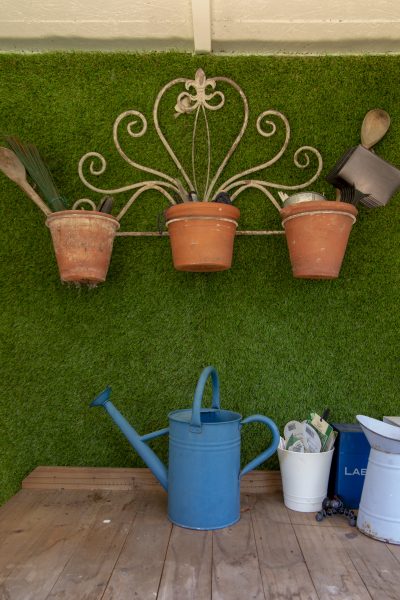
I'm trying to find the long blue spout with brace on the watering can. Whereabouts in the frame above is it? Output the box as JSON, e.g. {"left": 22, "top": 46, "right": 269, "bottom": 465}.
{"left": 90, "top": 386, "right": 169, "bottom": 490}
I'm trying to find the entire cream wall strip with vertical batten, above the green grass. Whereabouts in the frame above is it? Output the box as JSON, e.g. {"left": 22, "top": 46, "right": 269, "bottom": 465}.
{"left": 0, "top": 0, "right": 400, "bottom": 54}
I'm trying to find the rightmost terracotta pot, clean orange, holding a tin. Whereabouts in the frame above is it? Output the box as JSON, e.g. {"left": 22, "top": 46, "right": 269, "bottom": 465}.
{"left": 281, "top": 200, "right": 358, "bottom": 279}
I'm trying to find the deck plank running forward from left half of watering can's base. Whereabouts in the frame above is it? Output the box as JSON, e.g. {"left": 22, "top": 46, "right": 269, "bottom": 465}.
{"left": 157, "top": 526, "right": 212, "bottom": 600}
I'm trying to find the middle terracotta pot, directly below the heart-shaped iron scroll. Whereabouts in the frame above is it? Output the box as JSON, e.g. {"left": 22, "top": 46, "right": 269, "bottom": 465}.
{"left": 166, "top": 202, "right": 240, "bottom": 272}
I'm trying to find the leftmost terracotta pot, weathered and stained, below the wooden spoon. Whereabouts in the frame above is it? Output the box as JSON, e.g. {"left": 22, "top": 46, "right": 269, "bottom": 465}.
{"left": 46, "top": 210, "right": 119, "bottom": 284}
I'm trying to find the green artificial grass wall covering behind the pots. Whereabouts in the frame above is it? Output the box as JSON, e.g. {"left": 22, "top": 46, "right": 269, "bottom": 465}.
{"left": 0, "top": 53, "right": 400, "bottom": 501}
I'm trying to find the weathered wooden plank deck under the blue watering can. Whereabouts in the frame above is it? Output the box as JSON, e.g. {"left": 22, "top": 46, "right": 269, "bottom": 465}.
{"left": 0, "top": 469, "right": 400, "bottom": 600}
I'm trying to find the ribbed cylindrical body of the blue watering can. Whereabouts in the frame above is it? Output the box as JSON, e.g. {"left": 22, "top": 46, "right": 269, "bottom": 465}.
{"left": 168, "top": 409, "right": 241, "bottom": 529}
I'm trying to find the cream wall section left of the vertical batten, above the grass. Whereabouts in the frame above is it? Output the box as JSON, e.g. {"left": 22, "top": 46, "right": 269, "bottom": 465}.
{"left": 0, "top": 0, "right": 193, "bottom": 50}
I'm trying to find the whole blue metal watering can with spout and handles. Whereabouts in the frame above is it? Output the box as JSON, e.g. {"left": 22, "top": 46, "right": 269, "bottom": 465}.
{"left": 91, "top": 367, "right": 279, "bottom": 529}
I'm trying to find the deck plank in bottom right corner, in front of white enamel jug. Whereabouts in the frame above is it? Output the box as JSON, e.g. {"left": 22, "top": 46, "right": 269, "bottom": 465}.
{"left": 336, "top": 527, "right": 400, "bottom": 600}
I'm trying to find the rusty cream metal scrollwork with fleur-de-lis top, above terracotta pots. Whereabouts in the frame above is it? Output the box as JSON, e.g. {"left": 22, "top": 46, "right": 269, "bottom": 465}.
{"left": 78, "top": 69, "right": 323, "bottom": 235}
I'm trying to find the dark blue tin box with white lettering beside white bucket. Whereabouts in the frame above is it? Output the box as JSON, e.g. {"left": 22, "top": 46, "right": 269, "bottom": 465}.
{"left": 329, "top": 423, "right": 370, "bottom": 509}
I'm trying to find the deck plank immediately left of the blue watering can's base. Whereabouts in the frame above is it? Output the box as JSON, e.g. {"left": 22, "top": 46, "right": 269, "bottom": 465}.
{"left": 102, "top": 490, "right": 172, "bottom": 600}
